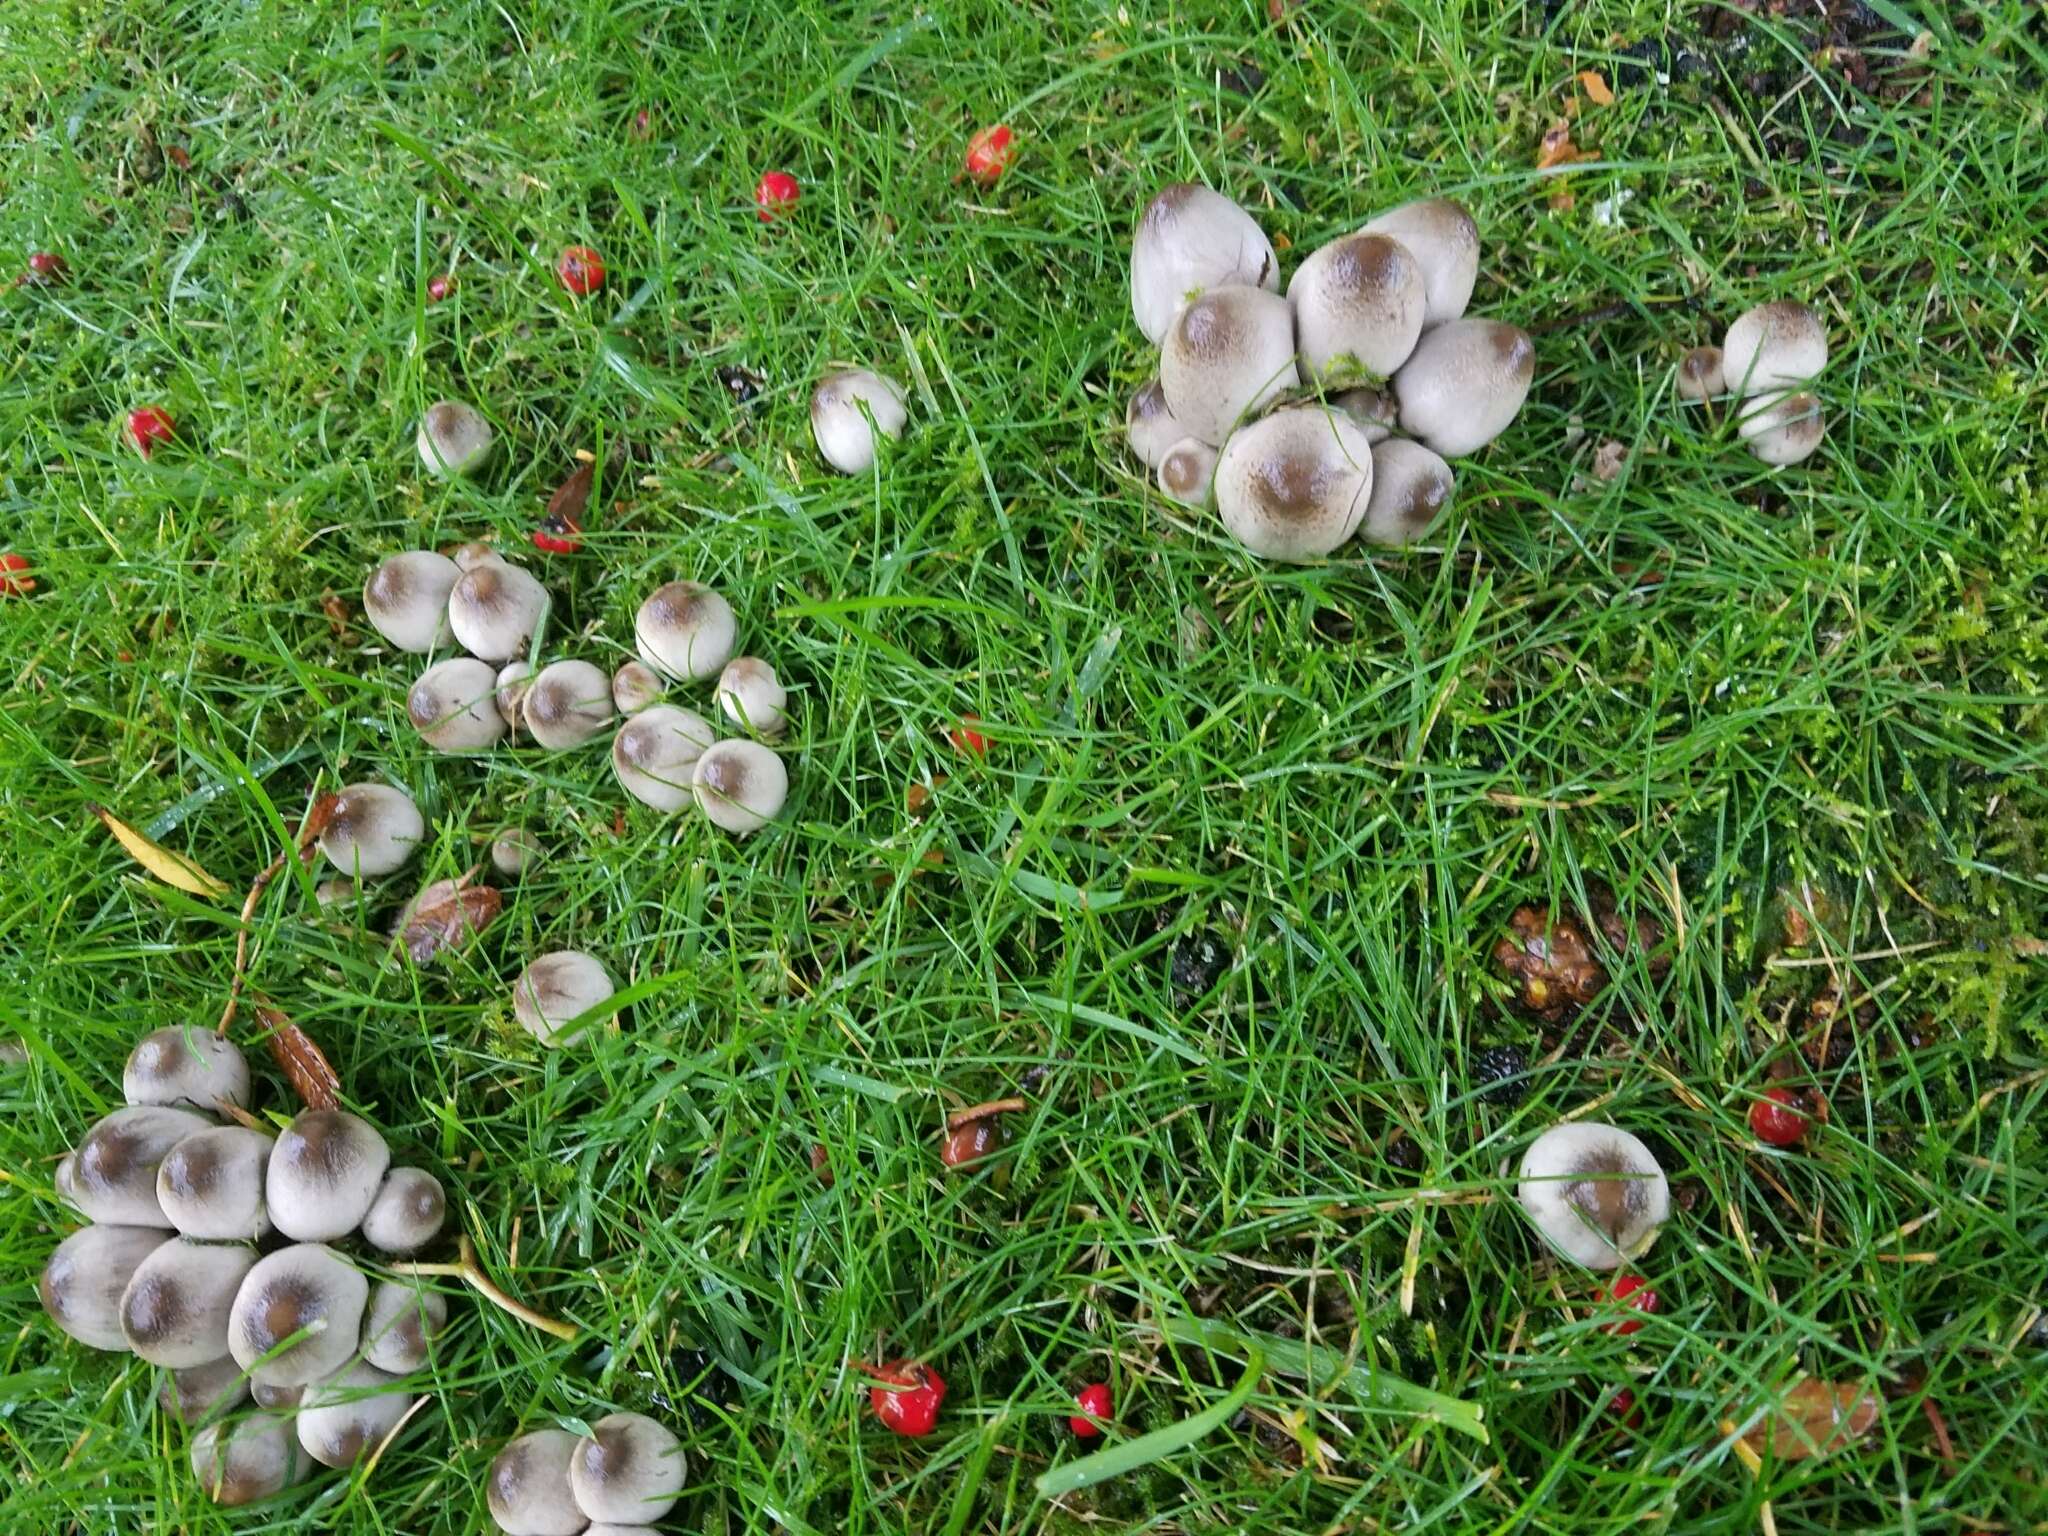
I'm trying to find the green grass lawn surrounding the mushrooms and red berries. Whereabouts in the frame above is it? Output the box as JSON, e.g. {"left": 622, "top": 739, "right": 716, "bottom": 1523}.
{"left": 0, "top": 0, "right": 2048, "bottom": 1536}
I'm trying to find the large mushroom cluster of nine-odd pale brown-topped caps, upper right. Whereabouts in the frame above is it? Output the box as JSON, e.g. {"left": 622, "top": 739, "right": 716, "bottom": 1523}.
{"left": 1124, "top": 182, "right": 1536, "bottom": 561}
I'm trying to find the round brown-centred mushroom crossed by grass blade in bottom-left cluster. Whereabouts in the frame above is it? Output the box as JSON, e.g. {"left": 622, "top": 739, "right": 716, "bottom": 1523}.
{"left": 227, "top": 1243, "right": 371, "bottom": 1386}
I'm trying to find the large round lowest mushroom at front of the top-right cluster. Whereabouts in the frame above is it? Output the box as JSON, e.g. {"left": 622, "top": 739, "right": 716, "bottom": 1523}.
{"left": 1217, "top": 406, "right": 1372, "bottom": 561}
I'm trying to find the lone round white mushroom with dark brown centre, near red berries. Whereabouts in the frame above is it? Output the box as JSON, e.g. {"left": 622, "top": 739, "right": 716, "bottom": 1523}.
{"left": 1516, "top": 1120, "right": 1671, "bottom": 1270}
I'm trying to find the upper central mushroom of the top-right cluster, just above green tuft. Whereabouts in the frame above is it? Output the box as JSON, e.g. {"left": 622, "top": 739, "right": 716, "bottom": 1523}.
{"left": 1286, "top": 236, "right": 1427, "bottom": 383}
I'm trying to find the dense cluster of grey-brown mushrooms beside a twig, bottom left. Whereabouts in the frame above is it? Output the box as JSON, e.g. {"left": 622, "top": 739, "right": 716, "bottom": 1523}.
{"left": 39, "top": 1028, "right": 449, "bottom": 1505}
